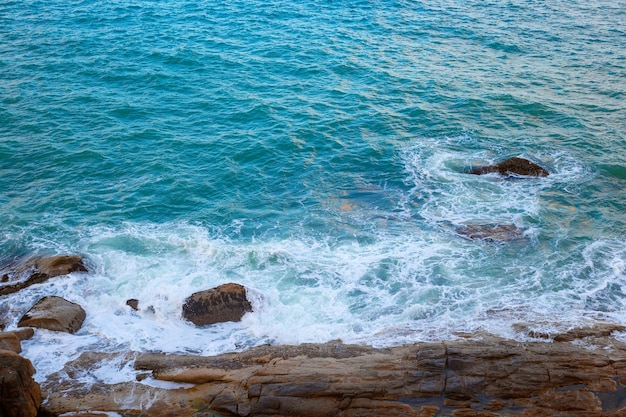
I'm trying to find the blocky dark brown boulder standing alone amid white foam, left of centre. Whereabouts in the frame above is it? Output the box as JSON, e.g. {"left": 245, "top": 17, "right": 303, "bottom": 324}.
{"left": 183, "top": 283, "right": 252, "bottom": 326}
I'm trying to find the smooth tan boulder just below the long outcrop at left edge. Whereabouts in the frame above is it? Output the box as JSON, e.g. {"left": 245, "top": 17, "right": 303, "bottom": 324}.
{"left": 18, "top": 296, "right": 86, "bottom": 333}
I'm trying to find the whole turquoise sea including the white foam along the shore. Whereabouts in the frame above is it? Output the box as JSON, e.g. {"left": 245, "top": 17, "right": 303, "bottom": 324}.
{"left": 0, "top": 0, "right": 626, "bottom": 380}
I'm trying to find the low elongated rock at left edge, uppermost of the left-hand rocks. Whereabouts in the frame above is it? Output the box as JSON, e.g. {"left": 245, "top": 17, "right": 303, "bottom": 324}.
{"left": 0, "top": 255, "right": 87, "bottom": 295}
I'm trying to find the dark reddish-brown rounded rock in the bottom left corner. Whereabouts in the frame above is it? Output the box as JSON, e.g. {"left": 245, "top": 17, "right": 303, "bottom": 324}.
{"left": 0, "top": 350, "right": 41, "bottom": 417}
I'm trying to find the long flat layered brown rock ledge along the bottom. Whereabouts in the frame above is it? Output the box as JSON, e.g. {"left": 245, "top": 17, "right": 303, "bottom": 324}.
{"left": 39, "top": 326, "right": 626, "bottom": 417}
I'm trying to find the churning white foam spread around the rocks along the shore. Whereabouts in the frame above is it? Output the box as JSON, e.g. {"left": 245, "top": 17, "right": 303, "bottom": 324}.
{"left": 9, "top": 138, "right": 626, "bottom": 384}
